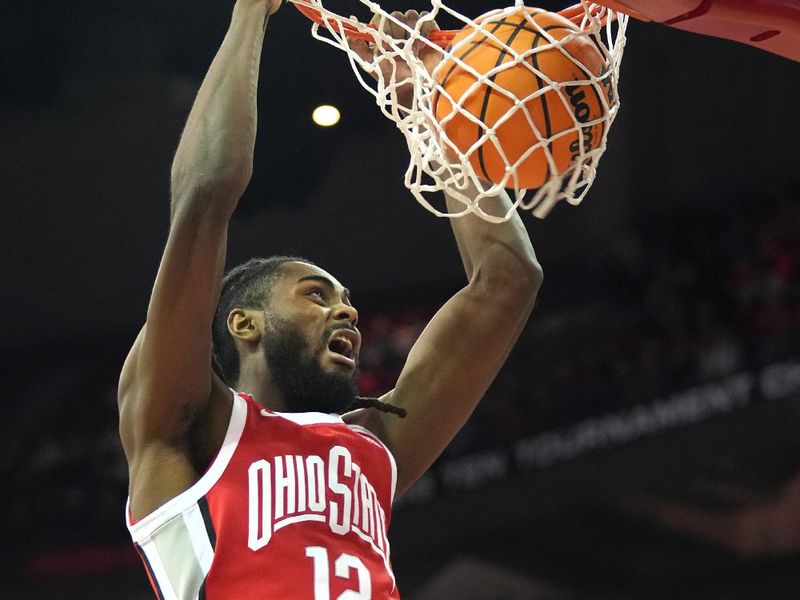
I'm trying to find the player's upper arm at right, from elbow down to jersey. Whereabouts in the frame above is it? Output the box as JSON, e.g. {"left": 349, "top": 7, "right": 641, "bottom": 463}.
{"left": 381, "top": 276, "right": 536, "bottom": 491}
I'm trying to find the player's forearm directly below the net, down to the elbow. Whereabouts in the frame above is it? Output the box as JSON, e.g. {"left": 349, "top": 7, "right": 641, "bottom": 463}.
{"left": 446, "top": 192, "right": 542, "bottom": 292}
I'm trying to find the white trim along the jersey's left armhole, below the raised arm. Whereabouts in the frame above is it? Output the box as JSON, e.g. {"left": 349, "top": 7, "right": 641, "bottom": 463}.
{"left": 125, "top": 392, "right": 247, "bottom": 543}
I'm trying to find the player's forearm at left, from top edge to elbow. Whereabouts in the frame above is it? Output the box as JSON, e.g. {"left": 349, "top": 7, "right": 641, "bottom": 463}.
{"left": 171, "top": 0, "right": 268, "bottom": 216}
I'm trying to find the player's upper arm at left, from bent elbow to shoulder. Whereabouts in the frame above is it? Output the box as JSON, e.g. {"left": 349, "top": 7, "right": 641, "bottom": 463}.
{"left": 119, "top": 209, "right": 227, "bottom": 448}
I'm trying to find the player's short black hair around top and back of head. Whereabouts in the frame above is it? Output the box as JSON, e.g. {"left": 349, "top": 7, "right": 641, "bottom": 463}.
{"left": 211, "top": 256, "right": 314, "bottom": 386}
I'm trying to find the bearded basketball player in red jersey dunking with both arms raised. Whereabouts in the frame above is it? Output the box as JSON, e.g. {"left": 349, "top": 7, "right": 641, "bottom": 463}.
{"left": 119, "top": 0, "right": 542, "bottom": 600}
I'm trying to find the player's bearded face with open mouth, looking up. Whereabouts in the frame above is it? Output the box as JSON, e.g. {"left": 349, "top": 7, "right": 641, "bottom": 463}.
{"left": 263, "top": 262, "right": 361, "bottom": 412}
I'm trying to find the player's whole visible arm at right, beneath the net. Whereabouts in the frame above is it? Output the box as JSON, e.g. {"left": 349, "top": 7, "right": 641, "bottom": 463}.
{"left": 377, "top": 193, "right": 542, "bottom": 493}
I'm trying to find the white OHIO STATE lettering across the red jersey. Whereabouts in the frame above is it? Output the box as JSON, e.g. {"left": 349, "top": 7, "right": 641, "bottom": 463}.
{"left": 247, "top": 446, "right": 389, "bottom": 557}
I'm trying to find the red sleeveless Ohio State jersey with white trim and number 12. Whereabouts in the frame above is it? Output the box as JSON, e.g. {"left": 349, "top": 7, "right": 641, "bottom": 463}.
{"left": 127, "top": 393, "right": 399, "bottom": 600}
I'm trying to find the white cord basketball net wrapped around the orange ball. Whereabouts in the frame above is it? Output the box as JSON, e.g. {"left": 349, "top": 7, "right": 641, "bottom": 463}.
{"left": 292, "top": 0, "right": 628, "bottom": 222}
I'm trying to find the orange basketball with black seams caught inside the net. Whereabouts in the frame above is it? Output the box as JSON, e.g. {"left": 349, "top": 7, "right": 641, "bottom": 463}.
{"left": 433, "top": 9, "right": 613, "bottom": 189}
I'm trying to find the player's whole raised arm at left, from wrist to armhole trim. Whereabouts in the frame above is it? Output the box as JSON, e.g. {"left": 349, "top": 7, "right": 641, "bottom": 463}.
{"left": 119, "top": 0, "right": 279, "bottom": 517}
